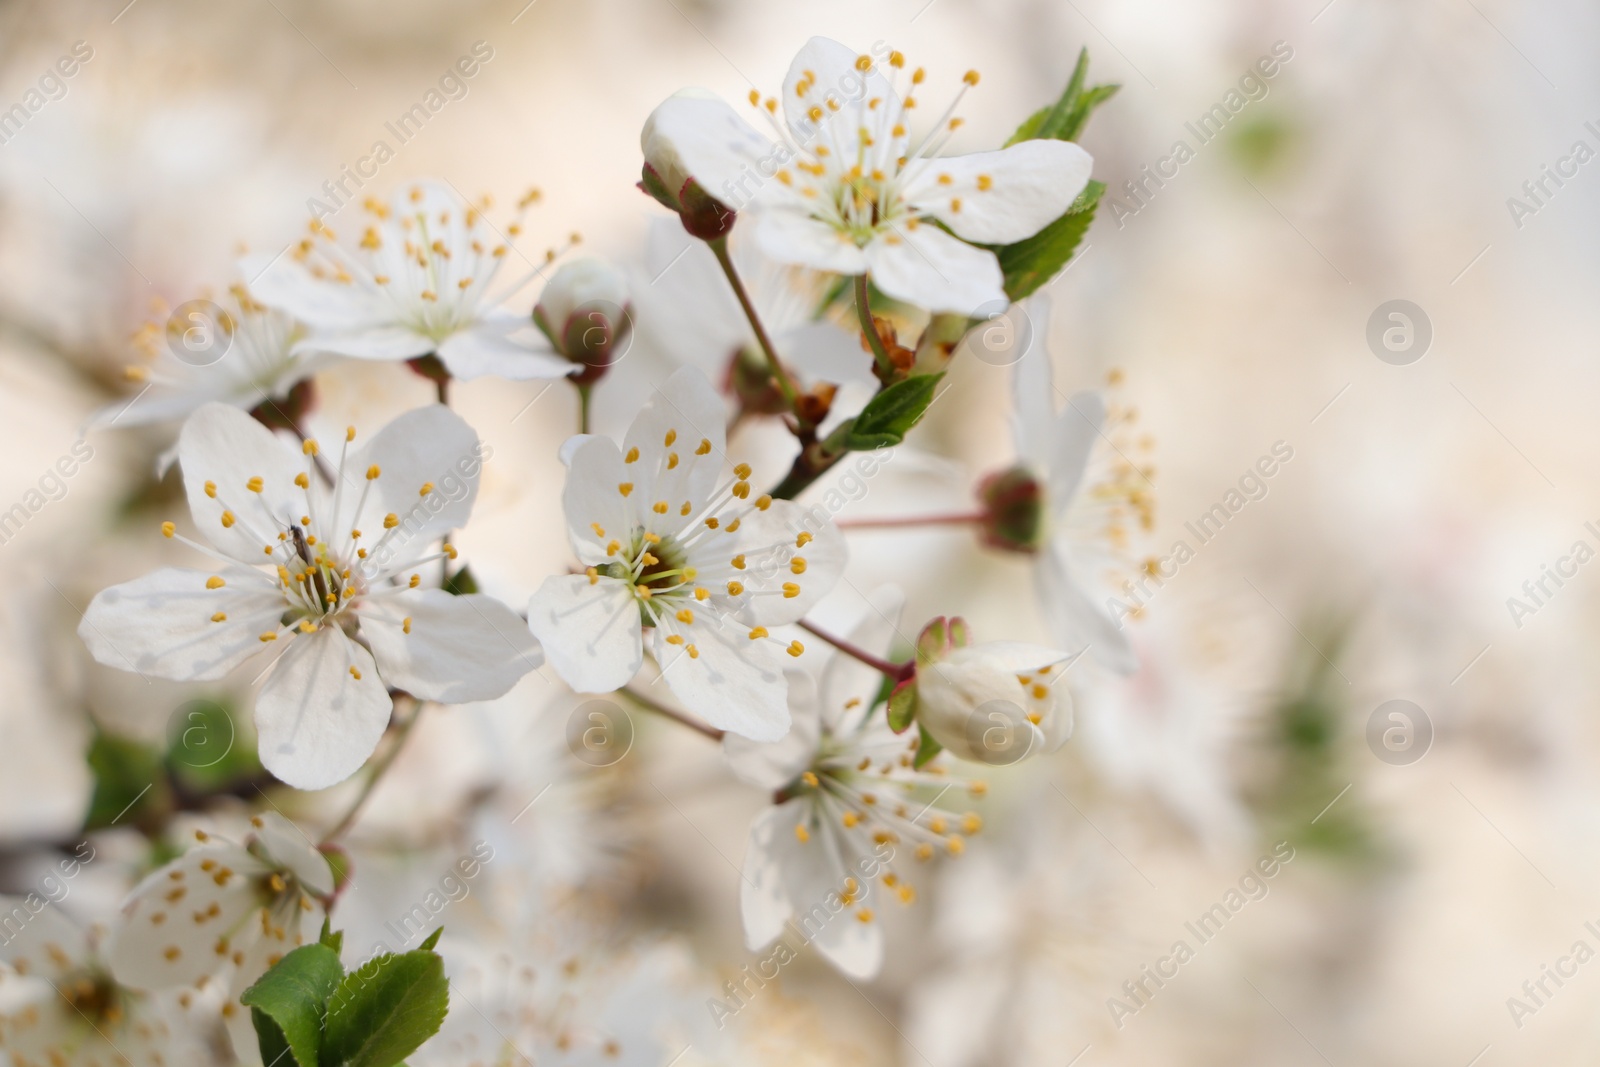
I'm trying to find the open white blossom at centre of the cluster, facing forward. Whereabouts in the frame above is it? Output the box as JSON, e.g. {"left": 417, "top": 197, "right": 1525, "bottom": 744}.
{"left": 528, "top": 368, "right": 845, "bottom": 741}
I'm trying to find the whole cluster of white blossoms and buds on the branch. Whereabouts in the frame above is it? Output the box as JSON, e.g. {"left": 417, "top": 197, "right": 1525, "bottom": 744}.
{"left": 0, "top": 38, "right": 1150, "bottom": 1067}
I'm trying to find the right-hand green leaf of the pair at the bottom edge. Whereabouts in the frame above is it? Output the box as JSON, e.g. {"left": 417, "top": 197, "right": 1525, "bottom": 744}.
{"left": 322, "top": 949, "right": 450, "bottom": 1067}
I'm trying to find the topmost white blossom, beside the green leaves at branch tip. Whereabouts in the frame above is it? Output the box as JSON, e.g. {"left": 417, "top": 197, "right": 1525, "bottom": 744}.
{"left": 642, "top": 37, "right": 1093, "bottom": 314}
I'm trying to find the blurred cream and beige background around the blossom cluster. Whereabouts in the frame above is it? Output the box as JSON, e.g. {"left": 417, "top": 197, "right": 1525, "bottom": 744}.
{"left": 0, "top": 0, "right": 1600, "bottom": 1067}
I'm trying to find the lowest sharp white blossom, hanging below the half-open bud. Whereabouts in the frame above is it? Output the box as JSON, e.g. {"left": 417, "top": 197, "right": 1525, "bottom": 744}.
{"left": 723, "top": 595, "right": 984, "bottom": 979}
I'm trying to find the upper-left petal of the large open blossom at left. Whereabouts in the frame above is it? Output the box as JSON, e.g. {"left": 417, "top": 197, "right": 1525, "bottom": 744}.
{"left": 178, "top": 403, "right": 315, "bottom": 566}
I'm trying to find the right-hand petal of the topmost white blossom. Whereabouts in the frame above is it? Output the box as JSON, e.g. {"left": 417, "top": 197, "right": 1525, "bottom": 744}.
{"left": 906, "top": 139, "right": 1094, "bottom": 245}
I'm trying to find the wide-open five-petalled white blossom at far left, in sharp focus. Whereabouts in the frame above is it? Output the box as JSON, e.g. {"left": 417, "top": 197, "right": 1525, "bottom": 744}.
{"left": 78, "top": 405, "right": 539, "bottom": 789}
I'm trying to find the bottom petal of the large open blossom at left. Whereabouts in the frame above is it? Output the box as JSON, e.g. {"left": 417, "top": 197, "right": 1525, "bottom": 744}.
{"left": 256, "top": 625, "right": 394, "bottom": 789}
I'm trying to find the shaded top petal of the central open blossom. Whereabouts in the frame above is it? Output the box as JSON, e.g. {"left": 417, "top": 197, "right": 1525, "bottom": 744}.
{"left": 622, "top": 366, "right": 728, "bottom": 536}
